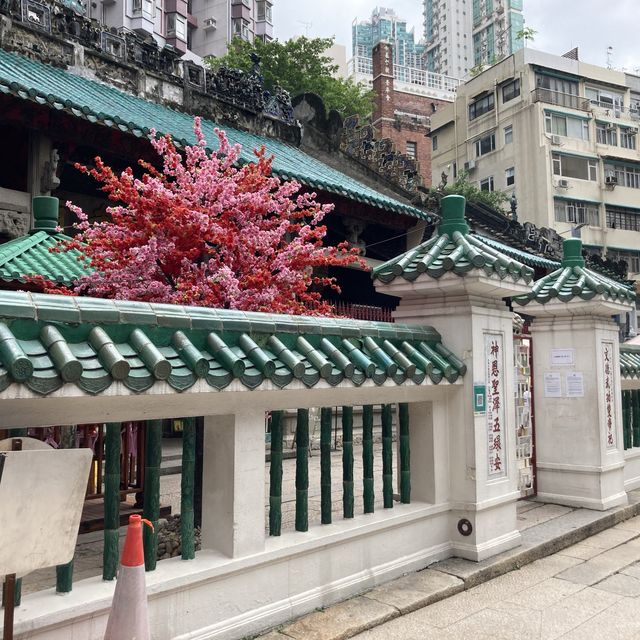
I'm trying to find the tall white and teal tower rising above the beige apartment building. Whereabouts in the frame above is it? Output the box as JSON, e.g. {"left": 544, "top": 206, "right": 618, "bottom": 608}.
{"left": 424, "top": 0, "right": 523, "bottom": 78}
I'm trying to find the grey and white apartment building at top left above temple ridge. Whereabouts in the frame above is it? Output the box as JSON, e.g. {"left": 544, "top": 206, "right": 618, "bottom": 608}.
{"left": 87, "top": 0, "right": 273, "bottom": 61}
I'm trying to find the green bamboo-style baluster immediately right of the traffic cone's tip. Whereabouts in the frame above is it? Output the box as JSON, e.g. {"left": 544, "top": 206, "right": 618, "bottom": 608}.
{"left": 142, "top": 420, "right": 162, "bottom": 571}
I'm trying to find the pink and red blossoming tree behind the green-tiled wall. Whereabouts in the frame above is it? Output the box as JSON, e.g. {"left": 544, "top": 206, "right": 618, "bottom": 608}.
{"left": 39, "top": 118, "right": 365, "bottom": 315}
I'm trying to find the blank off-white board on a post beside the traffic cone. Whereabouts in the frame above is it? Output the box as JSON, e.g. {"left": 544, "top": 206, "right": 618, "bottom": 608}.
{"left": 0, "top": 449, "right": 93, "bottom": 576}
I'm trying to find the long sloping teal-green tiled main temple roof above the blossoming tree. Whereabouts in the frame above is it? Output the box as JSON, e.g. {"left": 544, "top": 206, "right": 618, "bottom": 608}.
{"left": 0, "top": 50, "right": 430, "bottom": 220}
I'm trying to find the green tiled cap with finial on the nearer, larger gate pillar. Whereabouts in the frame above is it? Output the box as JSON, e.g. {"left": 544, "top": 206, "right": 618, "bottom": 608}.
{"left": 373, "top": 195, "right": 533, "bottom": 283}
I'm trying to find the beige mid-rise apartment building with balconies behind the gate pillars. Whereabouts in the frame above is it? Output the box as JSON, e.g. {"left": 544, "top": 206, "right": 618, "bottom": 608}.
{"left": 430, "top": 49, "right": 640, "bottom": 275}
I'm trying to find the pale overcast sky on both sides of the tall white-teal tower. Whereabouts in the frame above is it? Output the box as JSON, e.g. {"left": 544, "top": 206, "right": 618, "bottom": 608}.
{"left": 273, "top": 0, "right": 640, "bottom": 73}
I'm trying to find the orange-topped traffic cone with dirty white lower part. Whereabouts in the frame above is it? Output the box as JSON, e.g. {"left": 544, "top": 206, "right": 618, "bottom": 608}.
{"left": 104, "top": 515, "right": 151, "bottom": 640}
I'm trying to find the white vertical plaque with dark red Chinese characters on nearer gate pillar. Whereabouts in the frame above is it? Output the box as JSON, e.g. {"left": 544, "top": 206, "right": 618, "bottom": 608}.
{"left": 484, "top": 333, "right": 506, "bottom": 477}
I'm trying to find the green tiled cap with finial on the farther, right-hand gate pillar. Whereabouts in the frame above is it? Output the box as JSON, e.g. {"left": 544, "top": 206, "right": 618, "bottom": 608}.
{"left": 513, "top": 238, "right": 636, "bottom": 305}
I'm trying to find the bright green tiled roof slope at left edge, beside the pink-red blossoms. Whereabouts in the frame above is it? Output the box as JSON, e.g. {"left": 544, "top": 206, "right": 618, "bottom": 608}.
{"left": 0, "top": 231, "right": 90, "bottom": 285}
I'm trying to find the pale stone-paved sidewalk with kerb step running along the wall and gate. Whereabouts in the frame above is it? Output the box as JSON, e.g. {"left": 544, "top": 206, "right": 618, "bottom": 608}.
{"left": 260, "top": 491, "right": 640, "bottom": 640}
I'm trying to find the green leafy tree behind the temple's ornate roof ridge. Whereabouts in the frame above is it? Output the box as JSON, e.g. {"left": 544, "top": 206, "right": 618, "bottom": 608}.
{"left": 206, "top": 36, "right": 373, "bottom": 117}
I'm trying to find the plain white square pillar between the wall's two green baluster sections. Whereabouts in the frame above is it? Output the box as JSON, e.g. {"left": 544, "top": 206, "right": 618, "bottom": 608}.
{"left": 202, "top": 410, "right": 265, "bottom": 558}
